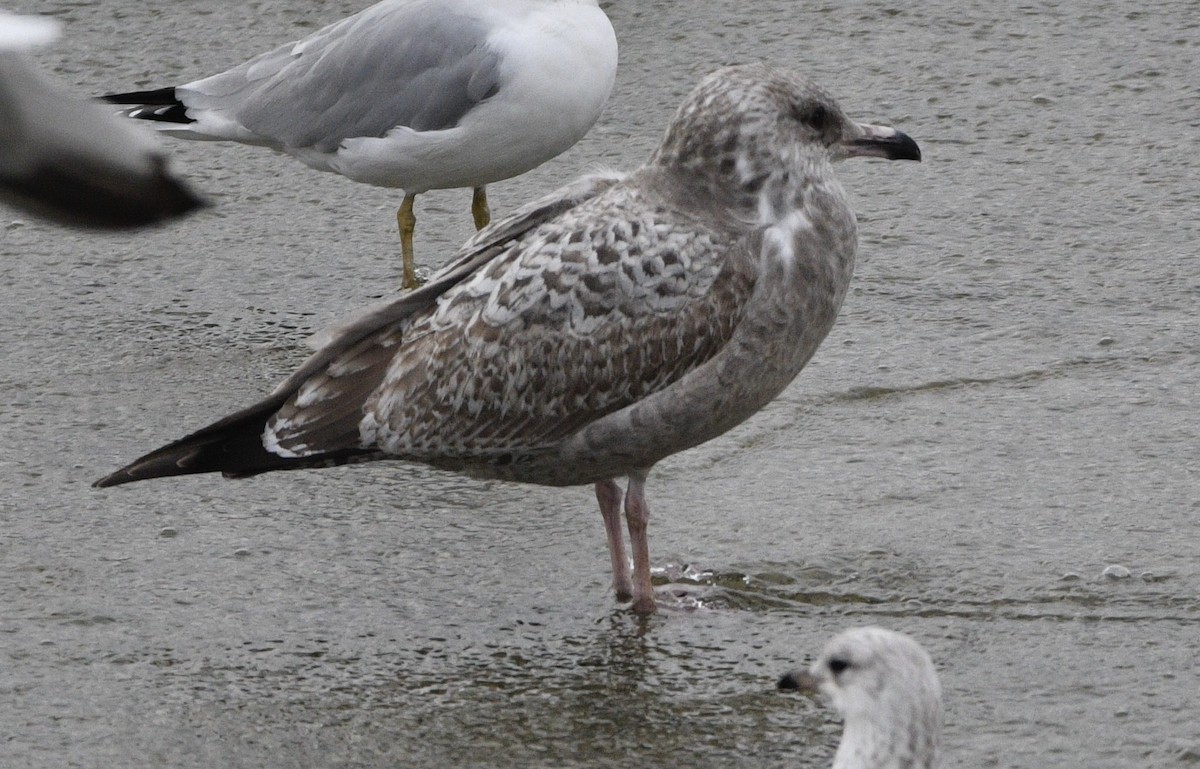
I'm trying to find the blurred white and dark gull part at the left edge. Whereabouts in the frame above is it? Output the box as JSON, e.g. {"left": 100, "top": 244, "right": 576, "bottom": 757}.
{"left": 0, "top": 12, "right": 202, "bottom": 228}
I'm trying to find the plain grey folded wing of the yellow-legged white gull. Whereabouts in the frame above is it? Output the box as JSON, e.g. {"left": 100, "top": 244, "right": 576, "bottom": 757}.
{"left": 189, "top": 0, "right": 499, "bottom": 152}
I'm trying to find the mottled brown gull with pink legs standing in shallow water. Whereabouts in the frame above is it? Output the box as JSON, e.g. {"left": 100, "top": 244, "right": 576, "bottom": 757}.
{"left": 97, "top": 65, "right": 920, "bottom": 612}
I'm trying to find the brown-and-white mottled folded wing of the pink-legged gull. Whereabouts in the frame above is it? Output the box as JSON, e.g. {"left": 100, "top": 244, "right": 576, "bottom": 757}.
{"left": 268, "top": 173, "right": 757, "bottom": 462}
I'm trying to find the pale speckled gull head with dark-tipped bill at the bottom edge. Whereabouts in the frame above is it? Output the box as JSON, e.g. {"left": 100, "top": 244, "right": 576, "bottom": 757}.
{"left": 779, "top": 627, "right": 942, "bottom": 769}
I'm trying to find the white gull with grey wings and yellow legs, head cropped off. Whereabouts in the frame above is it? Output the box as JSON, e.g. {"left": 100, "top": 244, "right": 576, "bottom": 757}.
{"left": 104, "top": 0, "right": 617, "bottom": 288}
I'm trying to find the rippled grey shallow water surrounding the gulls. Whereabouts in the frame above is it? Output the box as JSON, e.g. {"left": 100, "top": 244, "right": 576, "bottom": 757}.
{"left": 0, "top": 0, "right": 1200, "bottom": 769}
